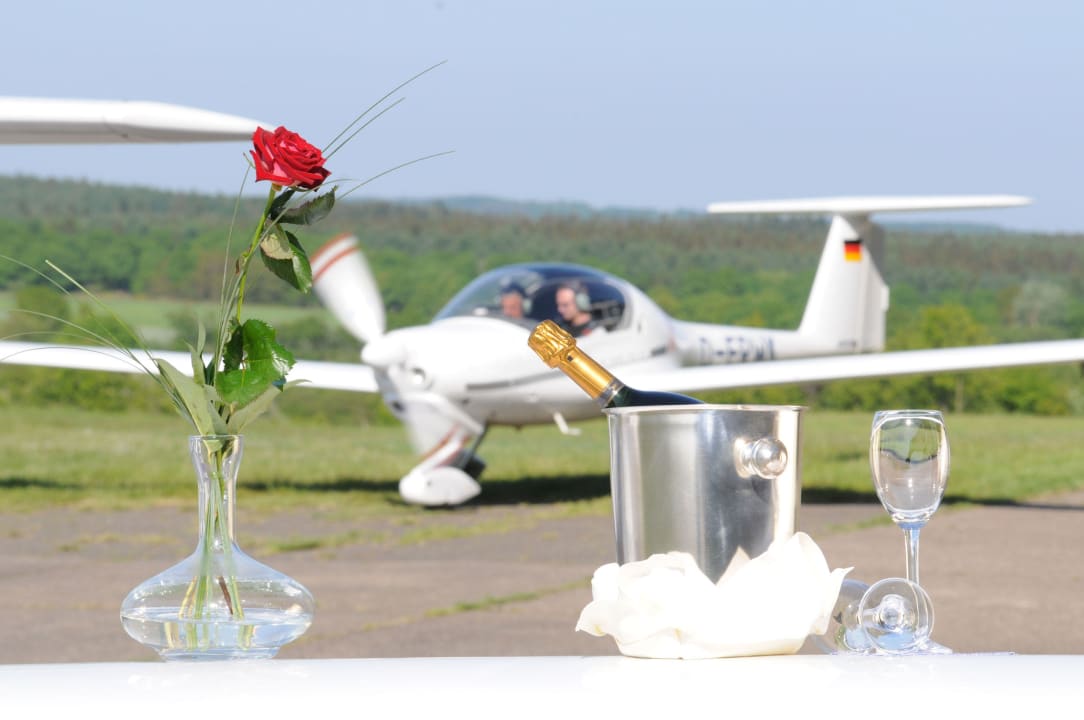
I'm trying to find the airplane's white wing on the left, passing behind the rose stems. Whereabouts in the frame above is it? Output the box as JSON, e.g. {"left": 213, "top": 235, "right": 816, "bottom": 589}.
{"left": 0, "top": 342, "right": 378, "bottom": 393}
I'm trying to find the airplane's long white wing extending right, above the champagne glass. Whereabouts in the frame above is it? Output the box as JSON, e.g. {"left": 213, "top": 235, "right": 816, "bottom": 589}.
{"left": 621, "top": 339, "right": 1084, "bottom": 391}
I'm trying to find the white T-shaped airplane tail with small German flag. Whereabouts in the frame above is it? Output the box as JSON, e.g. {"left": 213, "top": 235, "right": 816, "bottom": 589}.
{"left": 708, "top": 195, "right": 1031, "bottom": 352}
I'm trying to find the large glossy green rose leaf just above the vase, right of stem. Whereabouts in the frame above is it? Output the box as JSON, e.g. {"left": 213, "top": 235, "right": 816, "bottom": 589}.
{"left": 215, "top": 320, "right": 294, "bottom": 412}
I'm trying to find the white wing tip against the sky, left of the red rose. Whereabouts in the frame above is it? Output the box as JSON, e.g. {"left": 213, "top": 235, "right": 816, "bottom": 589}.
{"left": 0, "top": 98, "right": 274, "bottom": 145}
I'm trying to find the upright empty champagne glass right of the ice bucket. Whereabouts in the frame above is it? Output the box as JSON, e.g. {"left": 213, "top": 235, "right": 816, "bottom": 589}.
{"left": 860, "top": 410, "right": 950, "bottom": 652}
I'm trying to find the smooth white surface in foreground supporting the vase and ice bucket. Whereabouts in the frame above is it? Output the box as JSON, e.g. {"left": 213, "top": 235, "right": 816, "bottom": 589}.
{"left": 0, "top": 655, "right": 1084, "bottom": 720}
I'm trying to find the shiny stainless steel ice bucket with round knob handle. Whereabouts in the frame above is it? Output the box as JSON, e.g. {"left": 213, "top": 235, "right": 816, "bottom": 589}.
{"left": 605, "top": 404, "right": 803, "bottom": 580}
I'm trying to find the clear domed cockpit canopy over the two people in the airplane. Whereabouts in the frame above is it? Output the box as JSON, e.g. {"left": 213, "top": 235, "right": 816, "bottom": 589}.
{"left": 435, "top": 263, "right": 627, "bottom": 331}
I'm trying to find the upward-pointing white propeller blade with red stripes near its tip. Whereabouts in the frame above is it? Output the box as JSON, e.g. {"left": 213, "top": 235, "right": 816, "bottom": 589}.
{"left": 312, "top": 235, "right": 385, "bottom": 343}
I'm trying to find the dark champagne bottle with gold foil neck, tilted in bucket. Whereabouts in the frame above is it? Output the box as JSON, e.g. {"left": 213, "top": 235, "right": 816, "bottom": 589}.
{"left": 527, "top": 320, "right": 700, "bottom": 410}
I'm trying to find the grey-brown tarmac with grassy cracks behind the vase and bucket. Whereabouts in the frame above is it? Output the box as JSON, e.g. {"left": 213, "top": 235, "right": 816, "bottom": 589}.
{"left": 0, "top": 491, "right": 1084, "bottom": 664}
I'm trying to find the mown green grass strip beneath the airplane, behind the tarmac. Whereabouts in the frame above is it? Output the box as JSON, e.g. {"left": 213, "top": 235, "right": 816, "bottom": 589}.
{"left": 0, "top": 408, "right": 1084, "bottom": 514}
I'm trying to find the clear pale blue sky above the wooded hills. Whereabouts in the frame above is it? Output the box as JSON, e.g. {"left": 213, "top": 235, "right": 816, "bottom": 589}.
{"left": 0, "top": 0, "right": 1084, "bottom": 232}
